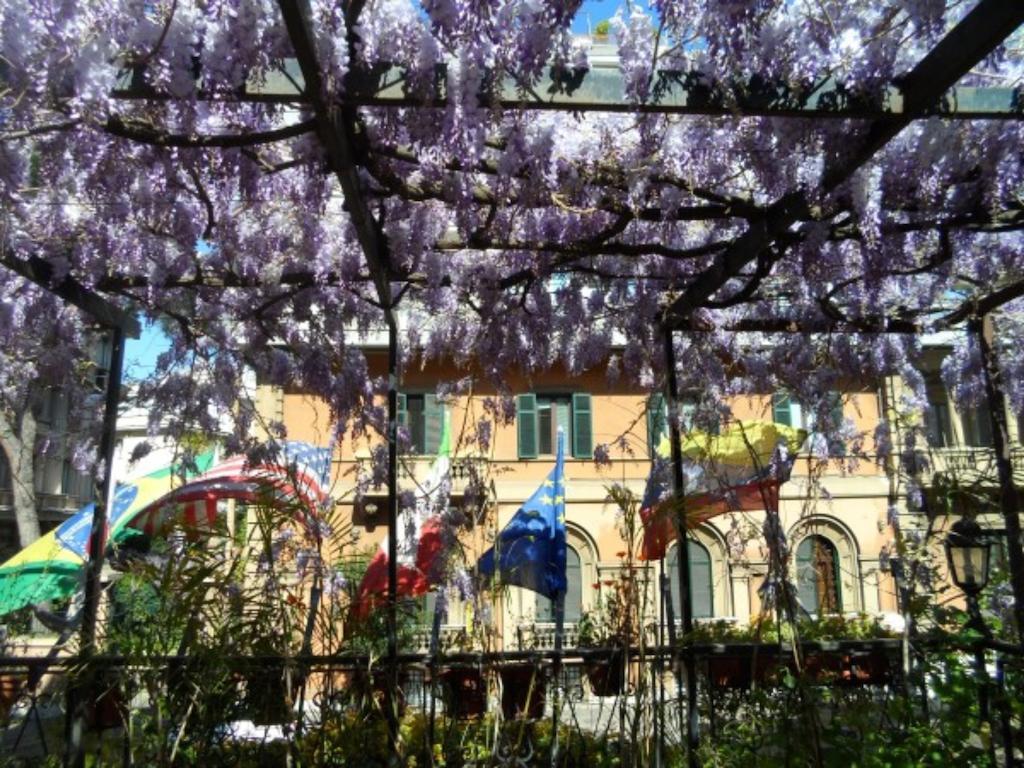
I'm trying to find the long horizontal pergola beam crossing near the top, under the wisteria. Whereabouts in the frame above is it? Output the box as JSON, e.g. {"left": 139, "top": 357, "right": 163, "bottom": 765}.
{"left": 114, "top": 61, "right": 1024, "bottom": 120}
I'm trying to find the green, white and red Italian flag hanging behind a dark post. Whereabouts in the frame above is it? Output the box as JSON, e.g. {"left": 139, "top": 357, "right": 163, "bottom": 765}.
{"left": 352, "top": 417, "right": 452, "bottom": 617}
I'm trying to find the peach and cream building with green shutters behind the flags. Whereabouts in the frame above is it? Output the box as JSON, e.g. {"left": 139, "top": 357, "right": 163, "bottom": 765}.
{"left": 258, "top": 339, "right": 1016, "bottom": 647}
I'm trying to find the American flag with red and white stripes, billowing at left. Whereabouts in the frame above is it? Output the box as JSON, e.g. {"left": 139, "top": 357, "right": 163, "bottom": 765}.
{"left": 127, "top": 441, "right": 333, "bottom": 535}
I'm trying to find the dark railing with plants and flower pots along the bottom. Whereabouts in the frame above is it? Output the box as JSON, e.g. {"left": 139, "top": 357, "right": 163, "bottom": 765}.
{"left": 0, "top": 640, "right": 1020, "bottom": 768}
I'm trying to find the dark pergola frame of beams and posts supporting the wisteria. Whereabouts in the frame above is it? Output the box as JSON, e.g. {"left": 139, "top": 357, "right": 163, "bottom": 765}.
{"left": 2, "top": 0, "right": 1024, "bottom": 761}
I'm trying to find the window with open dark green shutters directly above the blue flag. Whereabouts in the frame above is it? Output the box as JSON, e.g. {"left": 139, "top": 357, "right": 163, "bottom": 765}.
{"left": 516, "top": 392, "right": 594, "bottom": 459}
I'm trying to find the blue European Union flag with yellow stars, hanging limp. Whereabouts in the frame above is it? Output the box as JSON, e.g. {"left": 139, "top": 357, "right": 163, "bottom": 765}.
{"left": 477, "top": 429, "right": 565, "bottom": 599}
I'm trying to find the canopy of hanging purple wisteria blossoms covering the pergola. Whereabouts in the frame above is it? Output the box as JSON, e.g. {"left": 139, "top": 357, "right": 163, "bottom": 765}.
{"left": 0, "top": 0, "right": 1024, "bottom": 561}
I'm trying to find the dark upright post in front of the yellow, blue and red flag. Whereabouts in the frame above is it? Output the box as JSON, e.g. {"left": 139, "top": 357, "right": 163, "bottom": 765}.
{"left": 663, "top": 326, "right": 700, "bottom": 768}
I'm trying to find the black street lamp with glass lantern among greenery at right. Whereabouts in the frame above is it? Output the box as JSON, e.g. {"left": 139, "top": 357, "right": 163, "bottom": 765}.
{"left": 946, "top": 517, "right": 994, "bottom": 764}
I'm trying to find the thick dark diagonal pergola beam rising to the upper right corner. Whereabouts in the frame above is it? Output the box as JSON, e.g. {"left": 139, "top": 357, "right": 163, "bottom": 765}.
{"left": 664, "top": 0, "right": 1024, "bottom": 329}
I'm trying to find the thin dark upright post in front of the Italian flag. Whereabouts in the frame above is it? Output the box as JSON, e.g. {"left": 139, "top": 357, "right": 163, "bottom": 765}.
{"left": 384, "top": 312, "right": 398, "bottom": 751}
